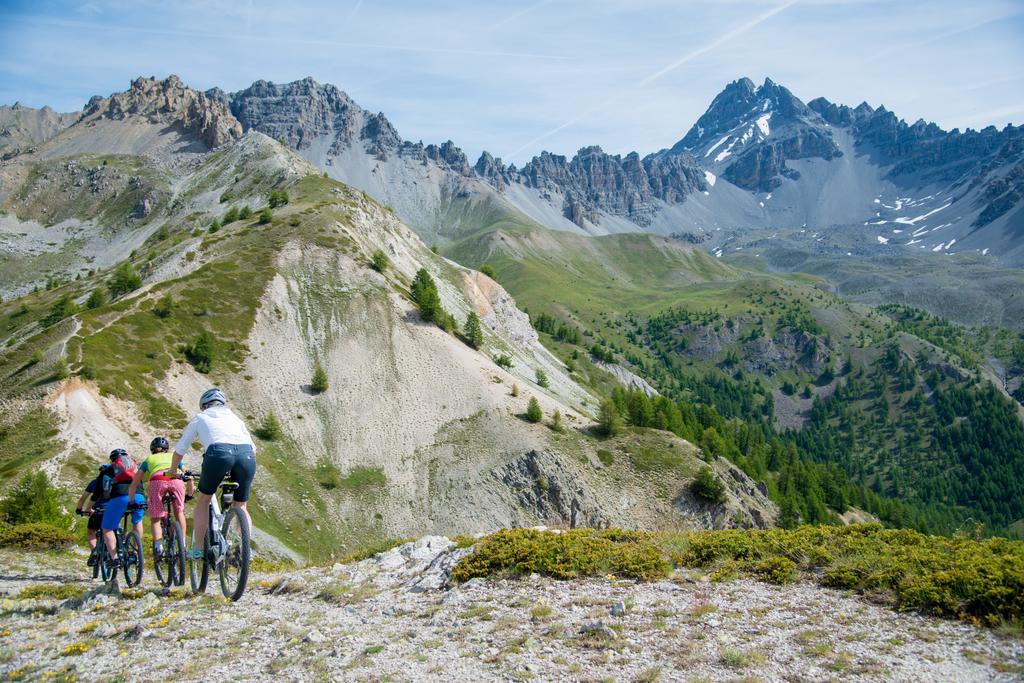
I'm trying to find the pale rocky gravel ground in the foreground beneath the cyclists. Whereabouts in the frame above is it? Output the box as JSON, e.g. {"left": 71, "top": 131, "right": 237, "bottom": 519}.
{"left": 0, "top": 537, "right": 1024, "bottom": 681}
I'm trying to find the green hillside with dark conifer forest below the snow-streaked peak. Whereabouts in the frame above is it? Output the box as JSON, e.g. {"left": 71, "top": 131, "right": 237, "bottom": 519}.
{"left": 460, "top": 229, "right": 1024, "bottom": 535}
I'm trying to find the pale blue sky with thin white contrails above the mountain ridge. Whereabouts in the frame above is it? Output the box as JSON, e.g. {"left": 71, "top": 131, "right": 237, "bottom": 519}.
{"left": 0, "top": 0, "right": 1024, "bottom": 163}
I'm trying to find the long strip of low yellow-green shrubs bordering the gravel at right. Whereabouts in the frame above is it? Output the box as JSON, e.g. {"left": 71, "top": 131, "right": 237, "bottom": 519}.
{"left": 452, "top": 524, "right": 1024, "bottom": 627}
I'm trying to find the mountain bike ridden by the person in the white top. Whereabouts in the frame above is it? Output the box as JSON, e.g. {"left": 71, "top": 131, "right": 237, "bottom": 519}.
{"left": 188, "top": 475, "right": 252, "bottom": 601}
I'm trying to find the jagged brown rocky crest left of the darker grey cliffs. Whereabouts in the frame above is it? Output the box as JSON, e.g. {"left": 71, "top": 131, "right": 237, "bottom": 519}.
{"left": 84, "top": 75, "right": 242, "bottom": 148}
